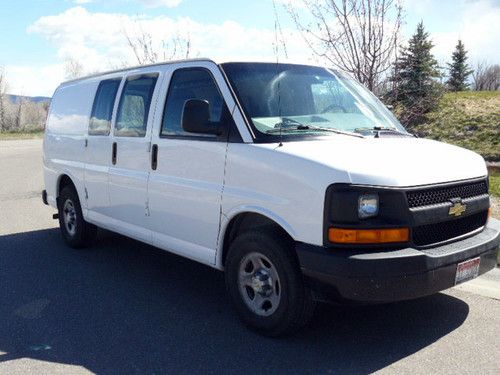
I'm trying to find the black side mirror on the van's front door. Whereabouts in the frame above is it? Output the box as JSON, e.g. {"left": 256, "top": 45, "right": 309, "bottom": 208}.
{"left": 181, "top": 99, "right": 221, "bottom": 135}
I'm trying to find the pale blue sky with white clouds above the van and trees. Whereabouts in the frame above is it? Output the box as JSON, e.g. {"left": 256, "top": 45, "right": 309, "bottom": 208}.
{"left": 0, "top": 0, "right": 500, "bottom": 96}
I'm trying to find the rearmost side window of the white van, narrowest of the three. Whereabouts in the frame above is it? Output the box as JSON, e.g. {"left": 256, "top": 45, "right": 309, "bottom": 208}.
{"left": 89, "top": 79, "right": 121, "bottom": 135}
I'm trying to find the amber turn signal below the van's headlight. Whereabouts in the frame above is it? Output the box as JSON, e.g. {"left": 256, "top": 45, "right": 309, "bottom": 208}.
{"left": 328, "top": 228, "right": 410, "bottom": 244}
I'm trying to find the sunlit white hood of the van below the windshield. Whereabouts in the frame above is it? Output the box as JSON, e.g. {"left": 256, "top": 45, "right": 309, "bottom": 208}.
{"left": 278, "top": 135, "right": 487, "bottom": 187}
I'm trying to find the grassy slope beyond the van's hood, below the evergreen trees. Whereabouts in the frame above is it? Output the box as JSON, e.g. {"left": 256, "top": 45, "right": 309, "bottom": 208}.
{"left": 415, "top": 91, "right": 500, "bottom": 161}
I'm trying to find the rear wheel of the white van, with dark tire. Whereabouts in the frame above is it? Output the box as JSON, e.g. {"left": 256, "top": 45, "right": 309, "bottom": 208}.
{"left": 58, "top": 186, "right": 97, "bottom": 249}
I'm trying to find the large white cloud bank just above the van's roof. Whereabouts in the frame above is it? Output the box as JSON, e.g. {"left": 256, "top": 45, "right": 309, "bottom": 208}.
{"left": 23, "top": 6, "right": 311, "bottom": 95}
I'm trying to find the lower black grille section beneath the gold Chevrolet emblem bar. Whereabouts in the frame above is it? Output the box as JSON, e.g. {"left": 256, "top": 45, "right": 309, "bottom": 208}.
{"left": 412, "top": 211, "right": 488, "bottom": 246}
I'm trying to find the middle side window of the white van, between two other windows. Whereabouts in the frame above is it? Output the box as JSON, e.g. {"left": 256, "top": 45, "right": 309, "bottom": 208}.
{"left": 115, "top": 74, "right": 158, "bottom": 137}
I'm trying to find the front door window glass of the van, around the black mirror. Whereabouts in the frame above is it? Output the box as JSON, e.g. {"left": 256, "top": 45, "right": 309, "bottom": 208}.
{"left": 161, "top": 68, "right": 225, "bottom": 138}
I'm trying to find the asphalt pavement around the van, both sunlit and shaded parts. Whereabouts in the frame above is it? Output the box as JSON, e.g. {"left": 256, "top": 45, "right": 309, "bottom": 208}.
{"left": 0, "top": 140, "right": 500, "bottom": 374}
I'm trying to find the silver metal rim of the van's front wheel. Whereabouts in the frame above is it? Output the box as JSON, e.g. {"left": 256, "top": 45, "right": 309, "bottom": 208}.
{"left": 238, "top": 252, "right": 281, "bottom": 316}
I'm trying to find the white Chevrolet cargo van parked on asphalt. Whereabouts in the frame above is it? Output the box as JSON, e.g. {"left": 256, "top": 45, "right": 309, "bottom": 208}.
{"left": 43, "top": 59, "right": 500, "bottom": 335}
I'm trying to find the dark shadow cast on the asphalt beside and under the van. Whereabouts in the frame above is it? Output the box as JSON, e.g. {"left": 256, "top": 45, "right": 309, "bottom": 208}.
{"left": 0, "top": 229, "right": 469, "bottom": 374}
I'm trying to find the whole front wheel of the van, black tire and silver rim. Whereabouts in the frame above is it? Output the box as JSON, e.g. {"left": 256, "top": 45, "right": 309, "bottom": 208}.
{"left": 225, "top": 227, "right": 315, "bottom": 337}
